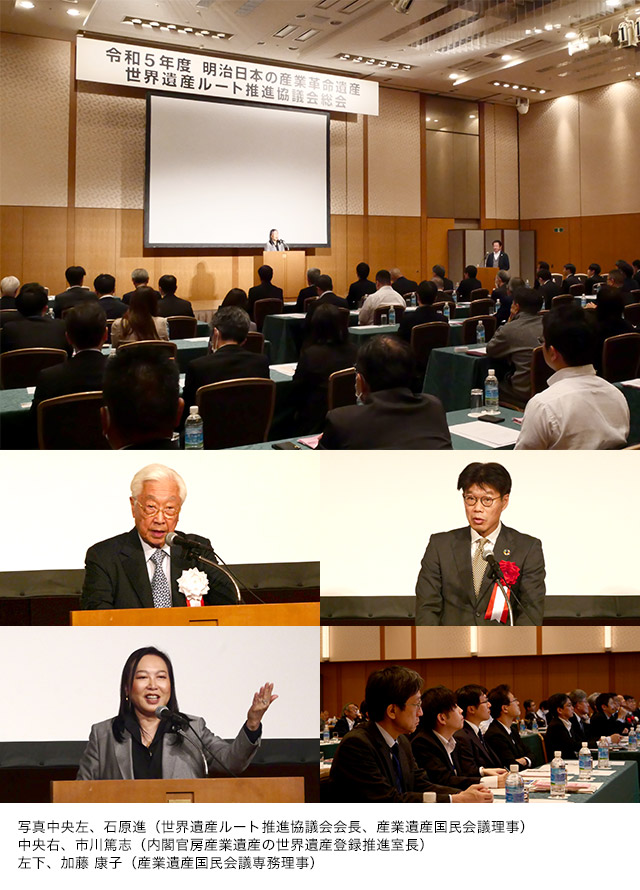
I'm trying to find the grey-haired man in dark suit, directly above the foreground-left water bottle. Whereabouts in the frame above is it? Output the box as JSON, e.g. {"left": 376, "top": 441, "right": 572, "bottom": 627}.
{"left": 184, "top": 306, "right": 269, "bottom": 417}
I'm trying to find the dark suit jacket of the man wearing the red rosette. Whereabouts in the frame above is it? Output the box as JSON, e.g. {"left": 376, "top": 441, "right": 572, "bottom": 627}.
{"left": 416, "top": 525, "right": 545, "bottom": 626}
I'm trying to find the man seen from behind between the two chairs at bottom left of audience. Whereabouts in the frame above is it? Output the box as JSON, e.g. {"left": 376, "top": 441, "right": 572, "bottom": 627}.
{"left": 100, "top": 346, "right": 184, "bottom": 450}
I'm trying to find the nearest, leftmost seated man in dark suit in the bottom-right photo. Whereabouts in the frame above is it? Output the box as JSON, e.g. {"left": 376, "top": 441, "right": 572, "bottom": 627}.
{"left": 331, "top": 665, "right": 493, "bottom": 803}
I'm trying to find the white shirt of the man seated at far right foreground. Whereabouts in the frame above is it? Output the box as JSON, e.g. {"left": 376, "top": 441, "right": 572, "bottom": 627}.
{"left": 516, "top": 365, "right": 629, "bottom": 449}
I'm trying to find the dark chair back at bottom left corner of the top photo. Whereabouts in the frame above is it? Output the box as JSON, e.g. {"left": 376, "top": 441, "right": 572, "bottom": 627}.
{"left": 38, "top": 392, "right": 110, "bottom": 450}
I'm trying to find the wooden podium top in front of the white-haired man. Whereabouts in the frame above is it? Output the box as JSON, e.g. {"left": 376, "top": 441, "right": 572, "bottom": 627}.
{"left": 69, "top": 602, "right": 320, "bottom": 627}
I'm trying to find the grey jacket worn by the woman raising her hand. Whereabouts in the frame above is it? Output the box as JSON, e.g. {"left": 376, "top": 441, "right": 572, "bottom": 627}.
{"left": 76, "top": 714, "right": 260, "bottom": 781}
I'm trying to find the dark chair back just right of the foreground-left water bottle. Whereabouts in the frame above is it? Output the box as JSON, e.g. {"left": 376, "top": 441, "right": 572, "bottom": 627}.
{"left": 196, "top": 377, "right": 276, "bottom": 448}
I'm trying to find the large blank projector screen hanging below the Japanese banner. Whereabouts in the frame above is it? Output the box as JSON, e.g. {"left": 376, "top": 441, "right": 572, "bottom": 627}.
{"left": 145, "top": 95, "right": 330, "bottom": 248}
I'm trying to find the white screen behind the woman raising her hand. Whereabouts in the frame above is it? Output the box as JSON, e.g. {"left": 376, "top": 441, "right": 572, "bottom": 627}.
{"left": 0, "top": 627, "right": 320, "bottom": 742}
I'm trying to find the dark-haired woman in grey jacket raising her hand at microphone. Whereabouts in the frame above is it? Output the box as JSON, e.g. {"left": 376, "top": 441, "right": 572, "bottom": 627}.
{"left": 77, "top": 646, "right": 278, "bottom": 780}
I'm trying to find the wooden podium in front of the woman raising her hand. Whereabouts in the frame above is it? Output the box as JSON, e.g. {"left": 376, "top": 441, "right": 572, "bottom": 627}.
{"left": 51, "top": 776, "right": 304, "bottom": 803}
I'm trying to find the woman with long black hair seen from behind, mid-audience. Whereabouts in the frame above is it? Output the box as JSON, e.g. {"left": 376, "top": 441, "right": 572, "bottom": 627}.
{"left": 292, "top": 303, "right": 357, "bottom": 435}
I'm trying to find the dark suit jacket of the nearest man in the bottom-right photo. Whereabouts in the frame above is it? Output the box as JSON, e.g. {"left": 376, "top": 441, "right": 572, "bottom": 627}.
{"left": 331, "top": 722, "right": 456, "bottom": 803}
